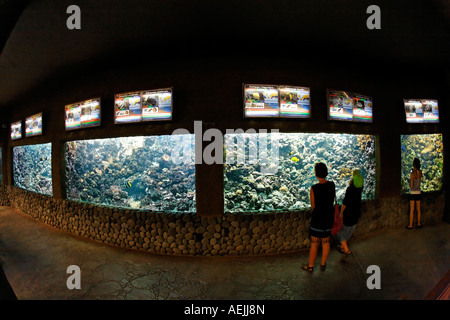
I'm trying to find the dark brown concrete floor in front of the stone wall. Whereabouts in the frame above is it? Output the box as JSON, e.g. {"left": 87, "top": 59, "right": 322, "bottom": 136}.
{"left": 0, "top": 207, "right": 450, "bottom": 300}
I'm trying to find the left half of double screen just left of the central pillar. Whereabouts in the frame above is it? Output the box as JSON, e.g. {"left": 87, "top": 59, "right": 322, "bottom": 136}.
{"left": 114, "top": 92, "right": 142, "bottom": 123}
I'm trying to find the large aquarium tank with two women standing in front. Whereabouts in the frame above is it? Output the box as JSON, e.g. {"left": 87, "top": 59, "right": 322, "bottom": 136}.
{"left": 224, "top": 133, "right": 376, "bottom": 213}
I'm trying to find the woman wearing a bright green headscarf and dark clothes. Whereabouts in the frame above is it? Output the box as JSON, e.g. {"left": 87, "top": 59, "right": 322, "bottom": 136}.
{"left": 336, "top": 170, "right": 364, "bottom": 256}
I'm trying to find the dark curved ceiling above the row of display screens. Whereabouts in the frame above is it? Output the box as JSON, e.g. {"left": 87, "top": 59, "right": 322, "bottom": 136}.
{"left": 0, "top": 0, "right": 450, "bottom": 108}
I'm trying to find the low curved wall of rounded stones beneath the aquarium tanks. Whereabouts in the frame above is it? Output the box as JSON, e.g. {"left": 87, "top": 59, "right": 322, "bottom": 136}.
{"left": 0, "top": 186, "right": 445, "bottom": 256}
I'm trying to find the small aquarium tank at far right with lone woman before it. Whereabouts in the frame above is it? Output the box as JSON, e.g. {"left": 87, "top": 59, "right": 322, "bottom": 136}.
{"left": 400, "top": 133, "right": 444, "bottom": 193}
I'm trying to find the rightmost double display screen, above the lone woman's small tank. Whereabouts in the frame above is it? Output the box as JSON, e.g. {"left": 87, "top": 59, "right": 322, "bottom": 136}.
{"left": 403, "top": 99, "right": 439, "bottom": 123}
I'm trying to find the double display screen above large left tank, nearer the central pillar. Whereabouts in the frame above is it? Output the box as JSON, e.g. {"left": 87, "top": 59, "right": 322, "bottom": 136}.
{"left": 114, "top": 88, "right": 172, "bottom": 123}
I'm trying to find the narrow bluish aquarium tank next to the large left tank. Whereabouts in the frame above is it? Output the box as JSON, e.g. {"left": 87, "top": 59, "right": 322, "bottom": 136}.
{"left": 13, "top": 143, "right": 53, "bottom": 196}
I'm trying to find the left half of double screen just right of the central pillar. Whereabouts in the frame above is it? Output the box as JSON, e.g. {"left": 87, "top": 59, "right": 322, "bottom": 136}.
{"left": 244, "top": 84, "right": 280, "bottom": 117}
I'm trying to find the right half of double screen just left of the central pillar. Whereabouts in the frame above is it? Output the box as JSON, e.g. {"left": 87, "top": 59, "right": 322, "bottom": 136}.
{"left": 142, "top": 89, "right": 172, "bottom": 121}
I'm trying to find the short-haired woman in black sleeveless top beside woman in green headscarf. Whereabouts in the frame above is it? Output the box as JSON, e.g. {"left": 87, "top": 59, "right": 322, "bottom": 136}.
{"left": 302, "top": 163, "right": 336, "bottom": 272}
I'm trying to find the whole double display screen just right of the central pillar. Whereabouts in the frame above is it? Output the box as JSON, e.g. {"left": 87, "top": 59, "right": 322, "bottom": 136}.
{"left": 244, "top": 84, "right": 311, "bottom": 118}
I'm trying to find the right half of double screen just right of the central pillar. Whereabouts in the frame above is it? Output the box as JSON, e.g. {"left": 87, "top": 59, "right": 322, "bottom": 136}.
{"left": 278, "top": 86, "right": 311, "bottom": 118}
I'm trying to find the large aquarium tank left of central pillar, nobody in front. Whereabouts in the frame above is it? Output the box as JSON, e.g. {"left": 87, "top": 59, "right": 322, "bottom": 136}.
{"left": 65, "top": 135, "right": 196, "bottom": 213}
